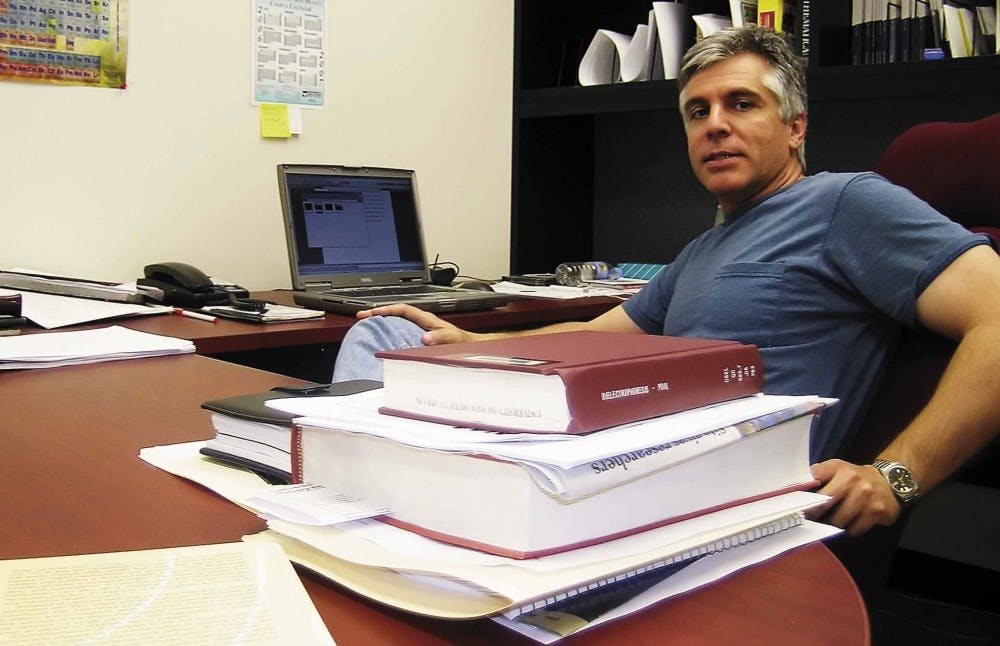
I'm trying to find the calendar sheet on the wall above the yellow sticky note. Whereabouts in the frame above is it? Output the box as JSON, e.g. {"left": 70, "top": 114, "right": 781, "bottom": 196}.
{"left": 254, "top": 0, "right": 326, "bottom": 108}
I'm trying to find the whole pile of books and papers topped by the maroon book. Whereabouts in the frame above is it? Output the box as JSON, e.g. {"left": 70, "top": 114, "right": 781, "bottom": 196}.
{"left": 162, "top": 332, "right": 838, "bottom": 641}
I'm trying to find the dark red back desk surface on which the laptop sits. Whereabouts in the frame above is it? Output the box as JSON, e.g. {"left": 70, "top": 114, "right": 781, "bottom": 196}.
{"left": 111, "top": 291, "right": 621, "bottom": 354}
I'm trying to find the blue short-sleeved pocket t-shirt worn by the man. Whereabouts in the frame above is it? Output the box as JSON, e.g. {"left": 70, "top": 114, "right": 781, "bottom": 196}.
{"left": 624, "top": 173, "right": 989, "bottom": 461}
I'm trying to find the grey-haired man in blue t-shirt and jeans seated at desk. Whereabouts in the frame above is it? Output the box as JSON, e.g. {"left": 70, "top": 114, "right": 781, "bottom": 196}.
{"left": 335, "top": 27, "right": 1000, "bottom": 535}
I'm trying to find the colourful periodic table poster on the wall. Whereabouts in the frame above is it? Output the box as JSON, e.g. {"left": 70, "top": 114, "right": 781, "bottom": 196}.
{"left": 0, "top": 0, "right": 128, "bottom": 89}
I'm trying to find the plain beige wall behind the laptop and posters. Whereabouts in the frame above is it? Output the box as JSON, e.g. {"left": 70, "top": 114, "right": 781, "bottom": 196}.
{"left": 0, "top": 0, "right": 513, "bottom": 289}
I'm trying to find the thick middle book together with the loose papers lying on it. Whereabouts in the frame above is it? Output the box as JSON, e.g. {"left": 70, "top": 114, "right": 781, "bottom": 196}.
{"left": 269, "top": 391, "right": 827, "bottom": 559}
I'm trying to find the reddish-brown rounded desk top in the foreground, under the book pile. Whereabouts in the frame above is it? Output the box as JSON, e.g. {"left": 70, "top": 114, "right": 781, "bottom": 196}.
{"left": 0, "top": 356, "right": 869, "bottom": 646}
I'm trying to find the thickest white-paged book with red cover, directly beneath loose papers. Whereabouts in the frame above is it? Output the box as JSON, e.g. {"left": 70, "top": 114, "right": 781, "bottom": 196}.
{"left": 290, "top": 400, "right": 824, "bottom": 558}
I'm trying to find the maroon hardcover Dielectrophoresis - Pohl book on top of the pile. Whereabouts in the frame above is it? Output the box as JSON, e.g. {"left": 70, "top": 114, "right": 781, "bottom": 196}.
{"left": 376, "top": 331, "right": 764, "bottom": 434}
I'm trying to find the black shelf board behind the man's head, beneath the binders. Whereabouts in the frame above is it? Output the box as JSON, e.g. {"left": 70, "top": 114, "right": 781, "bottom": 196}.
{"left": 517, "top": 56, "right": 1000, "bottom": 118}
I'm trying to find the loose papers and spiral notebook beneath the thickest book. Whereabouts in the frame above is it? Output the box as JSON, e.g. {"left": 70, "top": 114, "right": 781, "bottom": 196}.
{"left": 140, "top": 442, "right": 839, "bottom": 643}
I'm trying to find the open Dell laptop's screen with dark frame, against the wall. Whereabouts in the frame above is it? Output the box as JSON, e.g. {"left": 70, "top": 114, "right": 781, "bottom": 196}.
{"left": 278, "top": 164, "right": 427, "bottom": 289}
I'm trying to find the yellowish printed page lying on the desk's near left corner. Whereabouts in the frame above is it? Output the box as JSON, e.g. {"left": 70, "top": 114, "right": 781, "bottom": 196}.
{"left": 0, "top": 542, "right": 334, "bottom": 646}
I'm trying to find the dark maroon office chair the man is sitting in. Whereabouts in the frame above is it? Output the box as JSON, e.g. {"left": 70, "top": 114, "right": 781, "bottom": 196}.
{"left": 831, "top": 113, "right": 1000, "bottom": 646}
